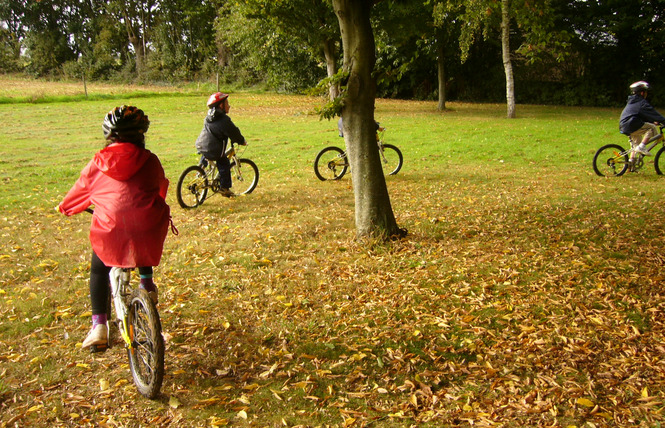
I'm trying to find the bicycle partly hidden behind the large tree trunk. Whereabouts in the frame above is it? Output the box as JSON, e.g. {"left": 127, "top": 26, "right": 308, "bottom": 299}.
{"left": 314, "top": 128, "right": 404, "bottom": 181}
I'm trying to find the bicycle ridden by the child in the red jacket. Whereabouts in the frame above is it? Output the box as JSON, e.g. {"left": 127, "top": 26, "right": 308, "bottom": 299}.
{"left": 86, "top": 208, "right": 164, "bottom": 399}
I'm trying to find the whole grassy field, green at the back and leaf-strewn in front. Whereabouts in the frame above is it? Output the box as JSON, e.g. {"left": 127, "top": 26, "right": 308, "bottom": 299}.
{"left": 0, "top": 78, "right": 665, "bottom": 427}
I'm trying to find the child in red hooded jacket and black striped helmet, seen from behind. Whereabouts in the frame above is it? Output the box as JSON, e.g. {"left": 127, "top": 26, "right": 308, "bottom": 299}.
{"left": 58, "top": 106, "right": 170, "bottom": 349}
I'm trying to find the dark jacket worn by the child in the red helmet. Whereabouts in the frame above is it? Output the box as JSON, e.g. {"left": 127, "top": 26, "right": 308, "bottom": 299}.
{"left": 195, "top": 107, "right": 245, "bottom": 159}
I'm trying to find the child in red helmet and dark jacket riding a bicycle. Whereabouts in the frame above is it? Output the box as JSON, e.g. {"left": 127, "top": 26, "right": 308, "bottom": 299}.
{"left": 195, "top": 92, "right": 247, "bottom": 197}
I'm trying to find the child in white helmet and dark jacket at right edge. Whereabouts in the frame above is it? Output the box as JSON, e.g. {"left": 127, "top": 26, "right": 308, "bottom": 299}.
{"left": 619, "top": 80, "right": 665, "bottom": 156}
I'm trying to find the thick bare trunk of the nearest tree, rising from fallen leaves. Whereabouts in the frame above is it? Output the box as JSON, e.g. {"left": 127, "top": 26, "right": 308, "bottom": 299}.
{"left": 333, "top": 0, "right": 401, "bottom": 239}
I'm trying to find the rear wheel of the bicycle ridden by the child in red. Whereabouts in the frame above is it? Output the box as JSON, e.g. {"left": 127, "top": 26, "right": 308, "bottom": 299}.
{"left": 127, "top": 288, "right": 164, "bottom": 398}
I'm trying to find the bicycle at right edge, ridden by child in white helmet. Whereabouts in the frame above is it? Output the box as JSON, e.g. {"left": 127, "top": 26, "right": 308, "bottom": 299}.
{"left": 593, "top": 124, "right": 665, "bottom": 177}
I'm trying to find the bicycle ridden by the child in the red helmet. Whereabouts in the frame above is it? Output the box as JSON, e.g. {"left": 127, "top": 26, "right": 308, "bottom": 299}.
{"left": 176, "top": 143, "right": 259, "bottom": 209}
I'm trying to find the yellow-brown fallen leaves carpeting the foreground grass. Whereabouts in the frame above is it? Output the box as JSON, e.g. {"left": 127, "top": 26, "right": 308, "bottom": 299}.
{"left": 0, "top": 155, "right": 665, "bottom": 427}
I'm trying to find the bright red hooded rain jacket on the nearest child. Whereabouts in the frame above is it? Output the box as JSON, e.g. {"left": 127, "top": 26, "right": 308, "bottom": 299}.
{"left": 59, "top": 142, "right": 170, "bottom": 267}
